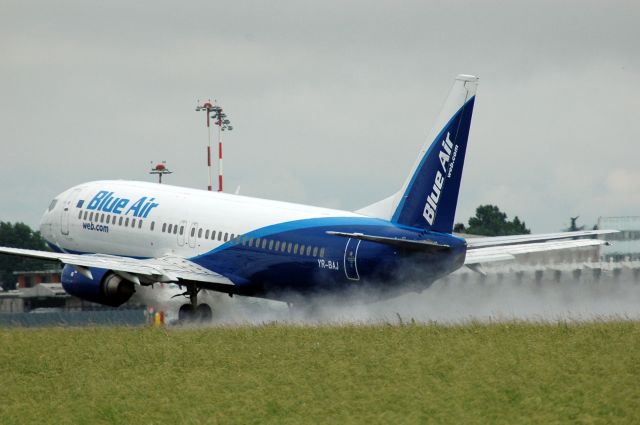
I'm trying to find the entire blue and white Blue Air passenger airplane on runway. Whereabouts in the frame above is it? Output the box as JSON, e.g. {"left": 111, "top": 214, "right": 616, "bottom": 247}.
{"left": 0, "top": 75, "right": 611, "bottom": 321}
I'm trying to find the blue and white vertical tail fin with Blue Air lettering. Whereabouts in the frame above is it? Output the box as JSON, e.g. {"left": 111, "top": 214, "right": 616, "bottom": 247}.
{"left": 391, "top": 75, "right": 478, "bottom": 233}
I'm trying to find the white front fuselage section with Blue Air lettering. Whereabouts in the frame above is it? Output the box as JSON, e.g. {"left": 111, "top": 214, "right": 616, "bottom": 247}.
{"left": 40, "top": 180, "right": 364, "bottom": 257}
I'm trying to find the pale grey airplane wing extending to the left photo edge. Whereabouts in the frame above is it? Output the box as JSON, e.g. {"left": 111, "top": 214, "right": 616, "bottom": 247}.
{"left": 0, "top": 247, "right": 233, "bottom": 285}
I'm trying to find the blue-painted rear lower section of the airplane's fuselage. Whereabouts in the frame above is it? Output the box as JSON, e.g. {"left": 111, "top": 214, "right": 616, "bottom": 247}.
{"left": 190, "top": 217, "right": 465, "bottom": 295}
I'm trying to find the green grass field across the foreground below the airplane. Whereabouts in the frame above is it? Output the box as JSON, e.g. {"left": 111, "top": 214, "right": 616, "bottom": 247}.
{"left": 0, "top": 322, "right": 640, "bottom": 424}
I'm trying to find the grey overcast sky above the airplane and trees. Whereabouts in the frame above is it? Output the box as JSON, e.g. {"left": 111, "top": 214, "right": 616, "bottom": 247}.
{"left": 0, "top": 0, "right": 640, "bottom": 232}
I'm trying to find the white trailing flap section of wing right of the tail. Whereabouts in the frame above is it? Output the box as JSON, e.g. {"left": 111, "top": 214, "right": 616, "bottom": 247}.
{"left": 464, "top": 231, "right": 612, "bottom": 265}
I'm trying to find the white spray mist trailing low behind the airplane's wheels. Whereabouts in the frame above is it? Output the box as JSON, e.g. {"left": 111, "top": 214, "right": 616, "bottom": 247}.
{"left": 138, "top": 263, "right": 640, "bottom": 326}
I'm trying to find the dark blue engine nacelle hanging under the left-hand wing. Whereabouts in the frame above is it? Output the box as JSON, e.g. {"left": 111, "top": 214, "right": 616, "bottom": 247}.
{"left": 61, "top": 265, "right": 136, "bottom": 307}
